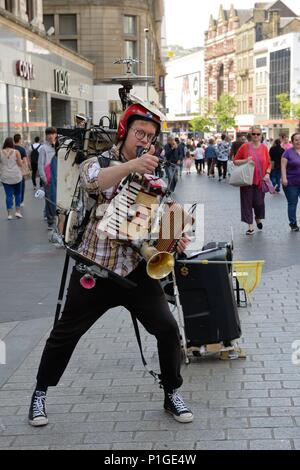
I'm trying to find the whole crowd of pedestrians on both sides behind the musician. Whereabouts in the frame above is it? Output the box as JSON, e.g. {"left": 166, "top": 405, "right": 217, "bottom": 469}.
{"left": 0, "top": 127, "right": 300, "bottom": 237}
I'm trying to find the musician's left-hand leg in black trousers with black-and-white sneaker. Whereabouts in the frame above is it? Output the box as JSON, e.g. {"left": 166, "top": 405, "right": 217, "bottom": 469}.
{"left": 29, "top": 269, "right": 116, "bottom": 426}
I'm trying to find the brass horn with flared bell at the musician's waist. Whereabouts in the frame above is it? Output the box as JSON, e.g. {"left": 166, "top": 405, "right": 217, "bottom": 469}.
{"left": 140, "top": 243, "right": 175, "bottom": 280}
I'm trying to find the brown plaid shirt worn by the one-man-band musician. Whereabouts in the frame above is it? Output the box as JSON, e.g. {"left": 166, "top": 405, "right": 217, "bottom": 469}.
{"left": 78, "top": 147, "right": 141, "bottom": 277}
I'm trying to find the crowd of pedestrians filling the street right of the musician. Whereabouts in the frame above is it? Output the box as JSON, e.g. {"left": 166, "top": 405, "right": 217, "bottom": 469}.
{"left": 159, "top": 126, "right": 300, "bottom": 236}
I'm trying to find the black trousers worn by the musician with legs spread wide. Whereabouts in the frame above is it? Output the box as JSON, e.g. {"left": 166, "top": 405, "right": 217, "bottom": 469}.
{"left": 37, "top": 262, "right": 182, "bottom": 390}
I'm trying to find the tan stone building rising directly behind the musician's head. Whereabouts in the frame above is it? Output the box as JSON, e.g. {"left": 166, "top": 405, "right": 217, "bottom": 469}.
{"left": 43, "top": 0, "right": 165, "bottom": 122}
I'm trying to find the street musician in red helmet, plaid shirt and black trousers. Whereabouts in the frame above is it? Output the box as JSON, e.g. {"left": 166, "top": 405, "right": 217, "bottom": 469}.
{"left": 29, "top": 104, "right": 193, "bottom": 426}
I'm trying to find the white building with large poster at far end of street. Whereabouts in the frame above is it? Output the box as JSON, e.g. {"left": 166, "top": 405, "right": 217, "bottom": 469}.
{"left": 166, "top": 49, "right": 204, "bottom": 134}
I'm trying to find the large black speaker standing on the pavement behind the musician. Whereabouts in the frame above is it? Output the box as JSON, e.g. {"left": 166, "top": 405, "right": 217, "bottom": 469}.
{"left": 175, "top": 243, "right": 241, "bottom": 347}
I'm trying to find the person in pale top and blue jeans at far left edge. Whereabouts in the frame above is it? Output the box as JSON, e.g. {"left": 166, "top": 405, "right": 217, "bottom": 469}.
{"left": 0, "top": 137, "right": 23, "bottom": 220}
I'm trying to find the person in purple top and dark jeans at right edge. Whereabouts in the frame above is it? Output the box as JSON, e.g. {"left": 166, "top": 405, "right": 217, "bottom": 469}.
{"left": 281, "top": 132, "right": 300, "bottom": 232}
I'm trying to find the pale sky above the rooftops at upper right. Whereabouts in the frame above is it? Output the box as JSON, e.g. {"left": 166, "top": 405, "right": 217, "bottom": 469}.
{"left": 165, "top": 0, "right": 300, "bottom": 48}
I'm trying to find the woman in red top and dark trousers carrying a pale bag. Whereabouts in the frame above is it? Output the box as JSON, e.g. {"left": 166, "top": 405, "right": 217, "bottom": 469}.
{"left": 234, "top": 126, "right": 272, "bottom": 235}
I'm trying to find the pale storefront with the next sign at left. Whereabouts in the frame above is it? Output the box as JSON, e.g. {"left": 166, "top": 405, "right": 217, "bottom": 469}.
{"left": 0, "top": 16, "right": 94, "bottom": 145}
